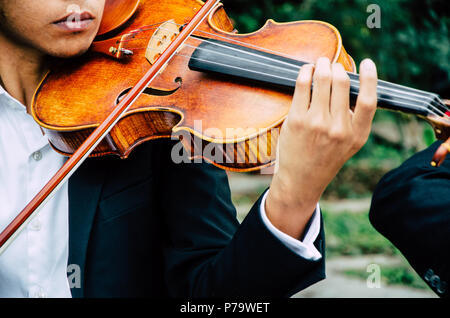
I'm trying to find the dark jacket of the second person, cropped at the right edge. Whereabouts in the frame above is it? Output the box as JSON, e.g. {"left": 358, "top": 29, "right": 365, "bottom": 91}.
{"left": 369, "top": 142, "right": 450, "bottom": 297}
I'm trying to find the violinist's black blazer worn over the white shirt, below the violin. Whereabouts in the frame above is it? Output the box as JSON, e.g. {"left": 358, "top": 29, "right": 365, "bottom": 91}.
{"left": 69, "top": 140, "right": 325, "bottom": 297}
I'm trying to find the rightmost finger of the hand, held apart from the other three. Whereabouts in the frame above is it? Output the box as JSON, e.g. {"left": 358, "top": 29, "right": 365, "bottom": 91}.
{"left": 353, "top": 59, "right": 378, "bottom": 136}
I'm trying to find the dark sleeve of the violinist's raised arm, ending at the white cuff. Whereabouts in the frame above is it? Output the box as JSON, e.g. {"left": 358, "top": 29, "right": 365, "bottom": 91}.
{"left": 156, "top": 140, "right": 325, "bottom": 297}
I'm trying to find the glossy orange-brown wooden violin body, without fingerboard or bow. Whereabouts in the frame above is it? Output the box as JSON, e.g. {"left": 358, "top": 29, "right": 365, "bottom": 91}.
{"left": 32, "top": 0, "right": 356, "bottom": 171}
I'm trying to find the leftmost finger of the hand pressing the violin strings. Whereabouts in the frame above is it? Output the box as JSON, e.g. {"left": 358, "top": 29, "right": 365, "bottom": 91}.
{"left": 290, "top": 64, "right": 314, "bottom": 113}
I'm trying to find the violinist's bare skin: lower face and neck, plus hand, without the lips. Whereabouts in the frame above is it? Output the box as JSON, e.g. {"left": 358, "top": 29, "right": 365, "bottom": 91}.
{"left": 0, "top": 0, "right": 377, "bottom": 238}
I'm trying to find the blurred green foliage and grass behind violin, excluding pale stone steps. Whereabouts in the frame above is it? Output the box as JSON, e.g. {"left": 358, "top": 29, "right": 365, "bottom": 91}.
{"left": 224, "top": 0, "right": 450, "bottom": 288}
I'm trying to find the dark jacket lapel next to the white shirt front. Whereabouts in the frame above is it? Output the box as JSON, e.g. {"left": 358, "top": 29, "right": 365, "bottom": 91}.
{"left": 68, "top": 160, "right": 104, "bottom": 298}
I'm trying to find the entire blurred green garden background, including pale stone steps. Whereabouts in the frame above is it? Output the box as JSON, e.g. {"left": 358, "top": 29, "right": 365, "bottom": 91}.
{"left": 224, "top": 0, "right": 450, "bottom": 297}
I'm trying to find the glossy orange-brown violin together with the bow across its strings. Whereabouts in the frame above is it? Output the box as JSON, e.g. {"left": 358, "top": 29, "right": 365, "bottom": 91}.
{"left": 0, "top": 0, "right": 450, "bottom": 252}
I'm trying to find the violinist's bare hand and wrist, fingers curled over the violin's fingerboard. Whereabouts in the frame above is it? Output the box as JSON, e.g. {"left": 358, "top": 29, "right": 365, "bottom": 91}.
{"left": 266, "top": 58, "right": 377, "bottom": 238}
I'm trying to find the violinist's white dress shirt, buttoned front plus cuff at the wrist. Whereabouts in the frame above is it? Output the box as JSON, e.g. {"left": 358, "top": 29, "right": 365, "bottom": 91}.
{"left": 0, "top": 86, "right": 322, "bottom": 297}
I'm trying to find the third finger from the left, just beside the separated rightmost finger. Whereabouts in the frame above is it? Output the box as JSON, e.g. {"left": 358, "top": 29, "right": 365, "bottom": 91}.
{"left": 330, "top": 63, "right": 350, "bottom": 124}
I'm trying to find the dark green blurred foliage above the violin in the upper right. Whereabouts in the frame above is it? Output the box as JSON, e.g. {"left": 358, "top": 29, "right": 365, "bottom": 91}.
{"left": 225, "top": 0, "right": 450, "bottom": 95}
